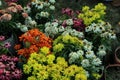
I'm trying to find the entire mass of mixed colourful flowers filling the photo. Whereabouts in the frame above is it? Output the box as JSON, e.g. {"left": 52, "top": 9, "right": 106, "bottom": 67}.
{"left": 0, "top": 0, "right": 117, "bottom": 80}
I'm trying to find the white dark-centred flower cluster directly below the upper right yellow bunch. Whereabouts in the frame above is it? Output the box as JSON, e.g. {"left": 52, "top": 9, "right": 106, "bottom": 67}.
{"left": 85, "top": 22, "right": 116, "bottom": 39}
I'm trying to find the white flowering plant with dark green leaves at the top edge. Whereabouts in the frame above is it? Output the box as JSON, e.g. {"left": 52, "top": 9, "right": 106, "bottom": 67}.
{"left": 24, "top": 0, "right": 55, "bottom": 24}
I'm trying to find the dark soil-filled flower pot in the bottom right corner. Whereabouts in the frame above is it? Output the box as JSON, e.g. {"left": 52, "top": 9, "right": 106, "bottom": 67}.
{"left": 103, "top": 64, "right": 120, "bottom": 80}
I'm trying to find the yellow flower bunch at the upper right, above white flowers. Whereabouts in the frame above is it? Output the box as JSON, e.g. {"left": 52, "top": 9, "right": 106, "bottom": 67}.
{"left": 78, "top": 3, "right": 106, "bottom": 26}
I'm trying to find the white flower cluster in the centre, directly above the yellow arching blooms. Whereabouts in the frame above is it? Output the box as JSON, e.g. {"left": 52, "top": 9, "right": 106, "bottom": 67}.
{"left": 45, "top": 22, "right": 84, "bottom": 38}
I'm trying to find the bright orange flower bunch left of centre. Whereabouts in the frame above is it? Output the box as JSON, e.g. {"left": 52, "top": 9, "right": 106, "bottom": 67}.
{"left": 15, "top": 29, "right": 52, "bottom": 57}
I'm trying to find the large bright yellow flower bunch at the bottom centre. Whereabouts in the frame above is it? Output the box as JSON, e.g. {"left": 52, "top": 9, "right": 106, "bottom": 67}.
{"left": 23, "top": 50, "right": 87, "bottom": 80}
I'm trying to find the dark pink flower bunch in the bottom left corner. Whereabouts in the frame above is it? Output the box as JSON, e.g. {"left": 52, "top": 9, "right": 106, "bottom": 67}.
{"left": 0, "top": 55, "right": 22, "bottom": 80}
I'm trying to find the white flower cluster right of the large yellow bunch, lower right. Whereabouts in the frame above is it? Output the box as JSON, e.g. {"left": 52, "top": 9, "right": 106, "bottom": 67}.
{"left": 69, "top": 39, "right": 102, "bottom": 71}
